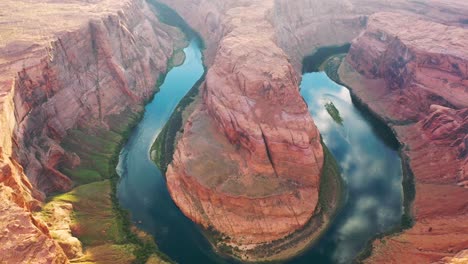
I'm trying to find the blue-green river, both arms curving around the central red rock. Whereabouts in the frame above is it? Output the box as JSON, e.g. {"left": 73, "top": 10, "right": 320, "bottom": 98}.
{"left": 117, "top": 37, "right": 403, "bottom": 263}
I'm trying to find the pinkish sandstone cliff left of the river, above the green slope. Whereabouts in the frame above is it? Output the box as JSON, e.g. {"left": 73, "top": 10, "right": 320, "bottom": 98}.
{"left": 0, "top": 0, "right": 184, "bottom": 263}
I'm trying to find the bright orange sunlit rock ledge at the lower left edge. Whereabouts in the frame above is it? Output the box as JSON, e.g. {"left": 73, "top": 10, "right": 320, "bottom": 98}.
{"left": 0, "top": 83, "right": 66, "bottom": 263}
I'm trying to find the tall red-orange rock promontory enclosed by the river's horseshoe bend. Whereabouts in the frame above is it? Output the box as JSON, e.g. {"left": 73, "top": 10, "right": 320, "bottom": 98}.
{"left": 167, "top": 1, "right": 323, "bottom": 256}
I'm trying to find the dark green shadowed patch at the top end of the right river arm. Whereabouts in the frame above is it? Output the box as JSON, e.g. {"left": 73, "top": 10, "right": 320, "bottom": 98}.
{"left": 302, "top": 43, "right": 351, "bottom": 73}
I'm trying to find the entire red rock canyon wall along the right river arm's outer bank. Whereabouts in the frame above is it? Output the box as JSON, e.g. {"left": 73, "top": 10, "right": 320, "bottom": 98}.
{"left": 340, "top": 13, "right": 468, "bottom": 263}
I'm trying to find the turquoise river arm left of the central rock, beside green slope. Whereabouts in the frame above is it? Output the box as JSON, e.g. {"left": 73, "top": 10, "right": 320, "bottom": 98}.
{"left": 117, "top": 40, "right": 227, "bottom": 263}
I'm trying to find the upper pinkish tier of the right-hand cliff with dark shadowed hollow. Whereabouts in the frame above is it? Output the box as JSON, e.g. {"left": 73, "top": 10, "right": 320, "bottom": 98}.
{"left": 348, "top": 13, "right": 468, "bottom": 121}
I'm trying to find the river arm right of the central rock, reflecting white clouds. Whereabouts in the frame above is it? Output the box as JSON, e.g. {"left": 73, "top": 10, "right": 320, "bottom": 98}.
{"left": 290, "top": 73, "right": 403, "bottom": 263}
